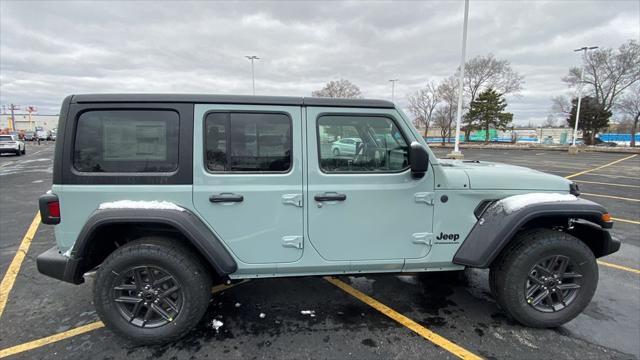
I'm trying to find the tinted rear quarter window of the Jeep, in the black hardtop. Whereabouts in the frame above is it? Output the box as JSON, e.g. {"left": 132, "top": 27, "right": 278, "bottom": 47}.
{"left": 73, "top": 110, "right": 180, "bottom": 173}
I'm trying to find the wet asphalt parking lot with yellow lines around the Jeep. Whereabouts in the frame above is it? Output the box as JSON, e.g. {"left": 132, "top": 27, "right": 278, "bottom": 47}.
{"left": 0, "top": 143, "right": 640, "bottom": 359}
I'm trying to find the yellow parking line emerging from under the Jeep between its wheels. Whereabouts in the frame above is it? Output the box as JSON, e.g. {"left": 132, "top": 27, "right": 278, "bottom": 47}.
{"left": 325, "top": 277, "right": 482, "bottom": 359}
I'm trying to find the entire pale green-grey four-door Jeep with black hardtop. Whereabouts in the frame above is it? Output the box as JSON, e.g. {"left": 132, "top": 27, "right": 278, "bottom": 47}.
{"left": 37, "top": 94, "right": 620, "bottom": 344}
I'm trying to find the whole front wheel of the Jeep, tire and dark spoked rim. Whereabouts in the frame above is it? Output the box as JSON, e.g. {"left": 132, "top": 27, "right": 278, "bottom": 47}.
{"left": 489, "top": 229, "right": 598, "bottom": 328}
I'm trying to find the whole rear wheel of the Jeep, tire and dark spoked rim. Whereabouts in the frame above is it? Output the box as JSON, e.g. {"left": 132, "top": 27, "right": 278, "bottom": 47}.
{"left": 94, "top": 238, "right": 212, "bottom": 344}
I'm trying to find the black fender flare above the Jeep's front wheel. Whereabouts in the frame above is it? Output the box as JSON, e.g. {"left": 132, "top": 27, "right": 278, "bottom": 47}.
{"left": 453, "top": 198, "right": 612, "bottom": 268}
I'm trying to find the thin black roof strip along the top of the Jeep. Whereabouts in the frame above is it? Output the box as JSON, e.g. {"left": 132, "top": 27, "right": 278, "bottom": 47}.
{"left": 71, "top": 94, "right": 395, "bottom": 108}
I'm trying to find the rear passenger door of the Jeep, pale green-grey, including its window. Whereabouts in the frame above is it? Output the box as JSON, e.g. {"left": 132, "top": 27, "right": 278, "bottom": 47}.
{"left": 193, "top": 105, "right": 303, "bottom": 266}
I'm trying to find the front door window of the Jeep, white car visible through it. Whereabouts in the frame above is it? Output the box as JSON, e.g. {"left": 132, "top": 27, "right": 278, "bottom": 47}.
{"left": 318, "top": 115, "right": 409, "bottom": 173}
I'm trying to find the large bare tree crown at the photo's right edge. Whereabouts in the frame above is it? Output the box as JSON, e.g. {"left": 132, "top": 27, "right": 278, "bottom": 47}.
{"left": 562, "top": 40, "right": 640, "bottom": 111}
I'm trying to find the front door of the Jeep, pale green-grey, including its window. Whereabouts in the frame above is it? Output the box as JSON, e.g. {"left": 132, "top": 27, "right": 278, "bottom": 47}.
{"left": 306, "top": 107, "right": 434, "bottom": 268}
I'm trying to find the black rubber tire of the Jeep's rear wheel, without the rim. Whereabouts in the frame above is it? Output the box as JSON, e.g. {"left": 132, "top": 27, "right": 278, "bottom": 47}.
{"left": 93, "top": 237, "right": 212, "bottom": 344}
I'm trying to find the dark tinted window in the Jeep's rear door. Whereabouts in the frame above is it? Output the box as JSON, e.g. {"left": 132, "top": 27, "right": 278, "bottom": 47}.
{"left": 204, "top": 112, "right": 292, "bottom": 172}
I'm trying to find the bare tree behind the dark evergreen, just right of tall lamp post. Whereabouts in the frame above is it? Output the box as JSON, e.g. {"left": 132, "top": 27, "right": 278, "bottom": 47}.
{"left": 456, "top": 54, "right": 524, "bottom": 139}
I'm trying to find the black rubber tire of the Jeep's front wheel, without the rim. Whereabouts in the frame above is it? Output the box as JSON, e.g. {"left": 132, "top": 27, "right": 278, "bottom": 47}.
{"left": 489, "top": 229, "right": 598, "bottom": 328}
